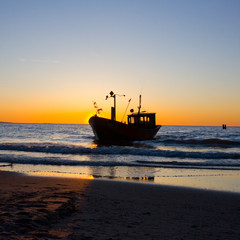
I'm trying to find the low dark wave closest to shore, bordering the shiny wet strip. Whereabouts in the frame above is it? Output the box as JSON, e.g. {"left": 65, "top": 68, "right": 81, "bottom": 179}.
{"left": 0, "top": 154, "right": 240, "bottom": 170}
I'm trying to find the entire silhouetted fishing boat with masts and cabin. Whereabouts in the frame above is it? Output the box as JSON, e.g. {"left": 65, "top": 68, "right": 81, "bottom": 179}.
{"left": 89, "top": 91, "right": 161, "bottom": 142}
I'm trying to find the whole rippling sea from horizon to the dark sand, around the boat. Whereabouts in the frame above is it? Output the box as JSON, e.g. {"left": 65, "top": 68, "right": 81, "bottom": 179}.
{"left": 0, "top": 123, "right": 240, "bottom": 193}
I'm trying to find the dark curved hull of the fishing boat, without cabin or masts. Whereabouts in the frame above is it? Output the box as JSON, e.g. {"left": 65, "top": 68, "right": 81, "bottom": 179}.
{"left": 89, "top": 116, "right": 160, "bottom": 142}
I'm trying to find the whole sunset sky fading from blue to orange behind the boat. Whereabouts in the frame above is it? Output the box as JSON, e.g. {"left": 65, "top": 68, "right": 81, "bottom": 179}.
{"left": 0, "top": 0, "right": 240, "bottom": 126}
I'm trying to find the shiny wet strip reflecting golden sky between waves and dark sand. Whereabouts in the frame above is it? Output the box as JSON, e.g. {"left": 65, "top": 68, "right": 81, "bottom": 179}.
{"left": 0, "top": 164, "right": 240, "bottom": 193}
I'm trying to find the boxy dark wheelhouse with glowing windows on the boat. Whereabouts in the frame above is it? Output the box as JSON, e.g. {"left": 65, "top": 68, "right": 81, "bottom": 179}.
{"left": 128, "top": 113, "right": 156, "bottom": 128}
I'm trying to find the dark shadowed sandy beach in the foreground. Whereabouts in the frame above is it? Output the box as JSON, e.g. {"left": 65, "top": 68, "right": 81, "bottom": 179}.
{"left": 0, "top": 171, "right": 240, "bottom": 240}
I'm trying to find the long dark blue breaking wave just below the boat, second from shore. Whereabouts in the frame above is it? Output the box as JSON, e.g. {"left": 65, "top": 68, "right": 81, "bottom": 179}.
{"left": 0, "top": 143, "right": 240, "bottom": 159}
